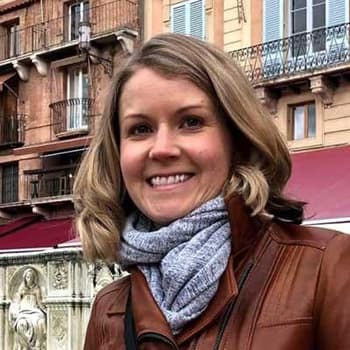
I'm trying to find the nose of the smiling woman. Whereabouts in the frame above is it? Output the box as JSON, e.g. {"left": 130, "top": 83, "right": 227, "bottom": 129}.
{"left": 149, "top": 127, "right": 180, "bottom": 160}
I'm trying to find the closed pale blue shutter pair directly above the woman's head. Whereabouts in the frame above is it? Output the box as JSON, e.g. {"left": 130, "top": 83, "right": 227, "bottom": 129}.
{"left": 171, "top": 0, "right": 205, "bottom": 39}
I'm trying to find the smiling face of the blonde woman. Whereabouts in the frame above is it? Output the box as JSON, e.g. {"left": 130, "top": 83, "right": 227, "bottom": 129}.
{"left": 119, "top": 68, "right": 232, "bottom": 224}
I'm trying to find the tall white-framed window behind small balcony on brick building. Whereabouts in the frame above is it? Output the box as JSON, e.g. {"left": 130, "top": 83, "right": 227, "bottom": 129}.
{"left": 67, "top": 68, "right": 88, "bottom": 130}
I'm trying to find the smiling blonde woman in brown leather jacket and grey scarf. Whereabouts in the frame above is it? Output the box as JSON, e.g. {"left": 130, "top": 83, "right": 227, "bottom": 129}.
{"left": 74, "top": 34, "right": 350, "bottom": 350}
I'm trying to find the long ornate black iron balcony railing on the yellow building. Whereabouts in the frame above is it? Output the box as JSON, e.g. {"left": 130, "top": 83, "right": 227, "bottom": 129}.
{"left": 230, "top": 23, "right": 350, "bottom": 83}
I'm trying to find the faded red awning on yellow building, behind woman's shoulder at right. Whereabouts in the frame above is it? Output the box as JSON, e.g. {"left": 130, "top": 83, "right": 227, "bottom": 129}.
{"left": 285, "top": 146, "right": 350, "bottom": 220}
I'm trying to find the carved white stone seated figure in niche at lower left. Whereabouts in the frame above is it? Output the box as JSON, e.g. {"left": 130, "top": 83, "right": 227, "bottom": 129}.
{"left": 9, "top": 267, "right": 46, "bottom": 350}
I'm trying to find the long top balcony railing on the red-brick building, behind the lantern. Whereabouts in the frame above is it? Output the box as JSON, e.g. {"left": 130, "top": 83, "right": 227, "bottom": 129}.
{"left": 0, "top": 0, "right": 139, "bottom": 60}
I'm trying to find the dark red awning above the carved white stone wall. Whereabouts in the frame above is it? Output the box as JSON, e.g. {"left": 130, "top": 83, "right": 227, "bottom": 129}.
{"left": 0, "top": 215, "right": 75, "bottom": 250}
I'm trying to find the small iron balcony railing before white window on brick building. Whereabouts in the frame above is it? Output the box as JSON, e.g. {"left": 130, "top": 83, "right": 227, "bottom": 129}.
{"left": 50, "top": 98, "right": 93, "bottom": 136}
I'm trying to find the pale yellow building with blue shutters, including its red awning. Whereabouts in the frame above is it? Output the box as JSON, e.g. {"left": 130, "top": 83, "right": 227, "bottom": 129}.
{"left": 144, "top": 0, "right": 350, "bottom": 233}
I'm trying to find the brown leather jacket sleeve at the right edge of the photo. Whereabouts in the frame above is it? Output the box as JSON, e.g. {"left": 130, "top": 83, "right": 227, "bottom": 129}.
{"left": 314, "top": 234, "right": 350, "bottom": 350}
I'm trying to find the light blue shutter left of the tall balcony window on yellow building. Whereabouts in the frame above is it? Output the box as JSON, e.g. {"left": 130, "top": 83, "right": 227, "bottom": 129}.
{"left": 263, "top": 0, "right": 283, "bottom": 42}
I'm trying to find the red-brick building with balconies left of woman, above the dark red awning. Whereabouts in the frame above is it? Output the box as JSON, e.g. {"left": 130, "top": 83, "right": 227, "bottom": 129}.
{"left": 0, "top": 0, "right": 139, "bottom": 218}
